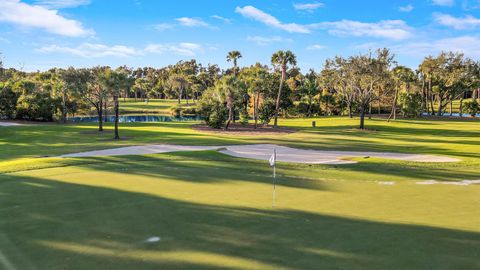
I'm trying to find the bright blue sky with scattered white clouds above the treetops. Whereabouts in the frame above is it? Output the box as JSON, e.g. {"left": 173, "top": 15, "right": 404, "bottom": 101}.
{"left": 0, "top": 0, "right": 480, "bottom": 72}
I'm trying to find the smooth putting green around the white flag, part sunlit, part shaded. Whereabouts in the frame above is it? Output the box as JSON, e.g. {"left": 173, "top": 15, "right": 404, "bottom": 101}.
{"left": 0, "top": 152, "right": 480, "bottom": 269}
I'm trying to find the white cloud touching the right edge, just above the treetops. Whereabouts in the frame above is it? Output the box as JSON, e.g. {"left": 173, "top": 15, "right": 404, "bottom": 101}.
{"left": 392, "top": 36, "right": 480, "bottom": 58}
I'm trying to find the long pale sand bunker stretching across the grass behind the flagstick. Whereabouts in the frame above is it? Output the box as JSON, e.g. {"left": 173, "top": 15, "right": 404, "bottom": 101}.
{"left": 61, "top": 144, "right": 460, "bottom": 164}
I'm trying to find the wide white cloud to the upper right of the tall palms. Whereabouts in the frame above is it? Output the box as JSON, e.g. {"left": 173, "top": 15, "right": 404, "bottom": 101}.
{"left": 311, "top": 20, "right": 412, "bottom": 40}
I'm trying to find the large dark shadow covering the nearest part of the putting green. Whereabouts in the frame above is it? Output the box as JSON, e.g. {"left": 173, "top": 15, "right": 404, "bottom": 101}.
{"left": 0, "top": 175, "right": 480, "bottom": 269}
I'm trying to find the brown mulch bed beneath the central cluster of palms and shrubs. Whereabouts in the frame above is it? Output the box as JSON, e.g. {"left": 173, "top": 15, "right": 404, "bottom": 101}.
{"left": 192, "top": 123, "right": 297, "bottom": 135}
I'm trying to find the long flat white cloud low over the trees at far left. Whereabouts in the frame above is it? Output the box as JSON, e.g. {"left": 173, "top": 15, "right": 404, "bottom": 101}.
{"left": 37, "top": 43, "right": 141, "bottom": 58}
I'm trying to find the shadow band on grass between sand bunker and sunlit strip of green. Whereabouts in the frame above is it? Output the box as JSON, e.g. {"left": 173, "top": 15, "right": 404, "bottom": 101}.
{"left": 80, "top": 151, "right": 329, "bottom": 190}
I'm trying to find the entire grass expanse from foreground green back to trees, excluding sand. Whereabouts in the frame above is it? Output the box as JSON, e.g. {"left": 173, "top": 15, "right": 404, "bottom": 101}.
{"left": 0, "top": 118, "right": 480, "bottom": 270}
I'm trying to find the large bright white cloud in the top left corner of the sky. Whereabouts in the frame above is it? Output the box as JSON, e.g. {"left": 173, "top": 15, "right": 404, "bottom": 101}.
{"left": 0, "top": 0, "right": 93, "bottom": 37}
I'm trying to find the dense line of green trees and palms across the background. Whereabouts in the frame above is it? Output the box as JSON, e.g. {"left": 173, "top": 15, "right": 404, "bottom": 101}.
{"left": 0, "top": 49, "right": 480, "bottom": 138}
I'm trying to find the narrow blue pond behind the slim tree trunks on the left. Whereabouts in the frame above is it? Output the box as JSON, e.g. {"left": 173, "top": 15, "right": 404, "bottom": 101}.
{"left": 68, "top": 115, "right": 202, "bottom": 123}
